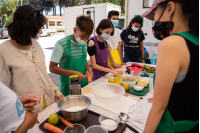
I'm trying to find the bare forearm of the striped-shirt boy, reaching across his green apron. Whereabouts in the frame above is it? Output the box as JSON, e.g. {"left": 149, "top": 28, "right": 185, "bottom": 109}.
{"left": 49, "top": 61, "right": 86, "bottom": 79}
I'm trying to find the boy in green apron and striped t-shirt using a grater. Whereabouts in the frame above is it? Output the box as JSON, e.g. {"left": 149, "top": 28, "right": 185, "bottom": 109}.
{"left": 49, "top": 15, "right": 94, "bottom": 96}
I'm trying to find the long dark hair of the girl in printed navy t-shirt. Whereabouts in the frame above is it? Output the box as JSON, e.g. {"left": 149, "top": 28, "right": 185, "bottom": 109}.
{"left": 124, "top": 16, "right": 143, "bottom": 40}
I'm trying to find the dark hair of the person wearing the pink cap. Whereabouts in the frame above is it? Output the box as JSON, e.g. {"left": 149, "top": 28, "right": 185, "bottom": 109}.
{"left": 159, "top": 0, "right": 199, "bottom": 36}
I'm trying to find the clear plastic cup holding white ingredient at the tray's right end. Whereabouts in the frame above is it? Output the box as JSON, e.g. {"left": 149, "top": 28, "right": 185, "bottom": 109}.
{"left": 99, "top": 113, "right": 120, "bottom": 131}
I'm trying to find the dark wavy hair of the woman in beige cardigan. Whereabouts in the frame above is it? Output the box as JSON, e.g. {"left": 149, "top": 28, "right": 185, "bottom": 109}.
{"left": 7, "top": 5, "right": 46, "bottom": 45}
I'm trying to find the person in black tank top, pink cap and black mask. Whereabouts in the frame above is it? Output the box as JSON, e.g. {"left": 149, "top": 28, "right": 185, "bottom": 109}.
{"left": 142, "top": 0, "right": 199, "bottom": 133}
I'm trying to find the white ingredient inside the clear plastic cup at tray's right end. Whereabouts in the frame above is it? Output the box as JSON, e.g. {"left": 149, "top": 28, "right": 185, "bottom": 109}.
{"left": 101, "top": 119, "right": 117, "bottom": 131}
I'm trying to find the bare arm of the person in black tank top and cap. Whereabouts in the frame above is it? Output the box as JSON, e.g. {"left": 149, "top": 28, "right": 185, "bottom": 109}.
{"left": 144, "top": 37, "right": 189, "bottom": 133}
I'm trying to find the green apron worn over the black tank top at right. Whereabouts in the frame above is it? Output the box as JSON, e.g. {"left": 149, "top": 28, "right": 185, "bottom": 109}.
{"left": 153, "top": 32, "right": 199, "bottom": 133}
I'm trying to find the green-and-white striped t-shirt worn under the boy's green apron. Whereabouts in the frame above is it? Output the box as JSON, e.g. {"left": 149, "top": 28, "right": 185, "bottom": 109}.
{"left": 51, "top": 37, "right": 87, "bottom": 68}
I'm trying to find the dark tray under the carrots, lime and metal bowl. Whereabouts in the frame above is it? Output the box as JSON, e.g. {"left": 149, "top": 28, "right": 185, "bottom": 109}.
{"left": 39, "top": 110, "right": 126, "bottom": 133}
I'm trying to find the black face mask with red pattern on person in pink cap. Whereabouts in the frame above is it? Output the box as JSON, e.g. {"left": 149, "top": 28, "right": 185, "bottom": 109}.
{"left": 152, "top": 7, "right": 174, "bottom": 40}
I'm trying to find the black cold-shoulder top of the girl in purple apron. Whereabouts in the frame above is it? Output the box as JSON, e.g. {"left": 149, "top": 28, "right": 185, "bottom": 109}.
{"left": 87, "top": 38, "right": 108, "bottom": 56}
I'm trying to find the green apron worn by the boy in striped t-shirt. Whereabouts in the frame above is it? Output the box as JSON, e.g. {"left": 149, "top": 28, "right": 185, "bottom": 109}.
{"left": 59, "top": 35, "right": 88, "bottom": 96}
